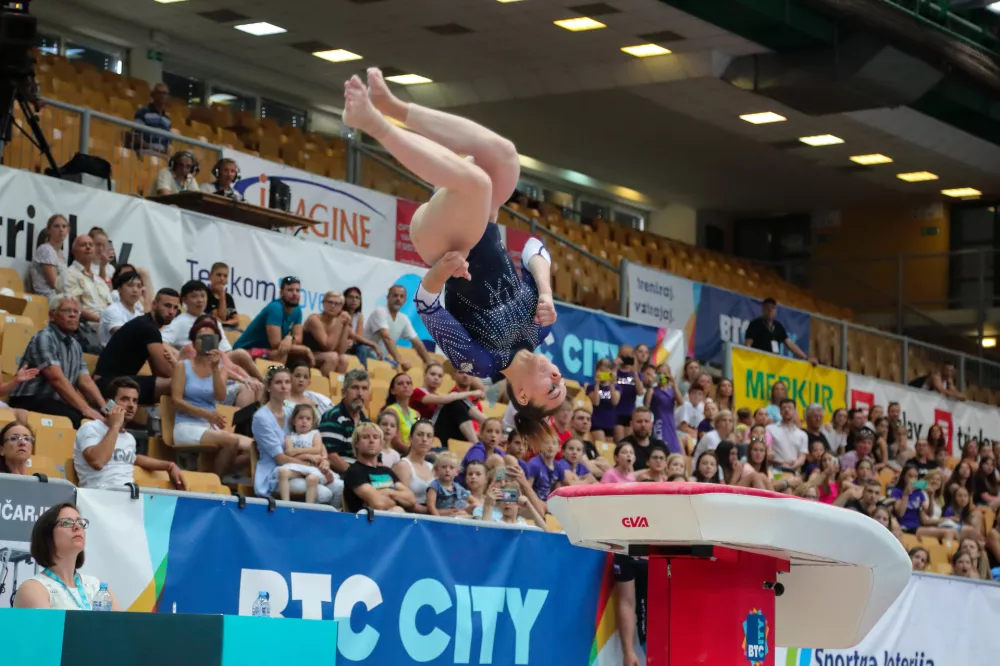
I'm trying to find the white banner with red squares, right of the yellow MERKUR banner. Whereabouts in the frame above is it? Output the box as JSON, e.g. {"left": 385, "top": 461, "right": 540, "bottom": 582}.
{"left": 847, "top": 373, "right": 1000, "bottom": 457}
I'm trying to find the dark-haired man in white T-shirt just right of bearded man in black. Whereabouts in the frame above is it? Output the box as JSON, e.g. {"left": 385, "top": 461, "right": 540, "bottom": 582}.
{"left": 160, "top": 280, "right": 264, "bottom": 407}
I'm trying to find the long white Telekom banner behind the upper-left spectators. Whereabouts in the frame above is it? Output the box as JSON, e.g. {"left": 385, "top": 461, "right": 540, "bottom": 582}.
{"left": 0, "top": 167, "right": 429, "bottom": 332}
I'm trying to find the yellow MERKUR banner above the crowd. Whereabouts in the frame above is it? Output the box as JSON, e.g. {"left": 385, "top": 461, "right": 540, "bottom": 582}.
{"left": 732, "top": 347, "right": 847, "bottom": 419}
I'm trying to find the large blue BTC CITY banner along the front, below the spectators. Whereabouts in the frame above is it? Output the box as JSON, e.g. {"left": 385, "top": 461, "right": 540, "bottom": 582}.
{"left": 77, "top": 490, "right": 608, "bottom": 666}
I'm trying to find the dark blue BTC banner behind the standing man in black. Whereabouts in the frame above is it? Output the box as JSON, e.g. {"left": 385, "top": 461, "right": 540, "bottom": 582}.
{"left": 692, "top": 284, "right": 809, "bottom": 365}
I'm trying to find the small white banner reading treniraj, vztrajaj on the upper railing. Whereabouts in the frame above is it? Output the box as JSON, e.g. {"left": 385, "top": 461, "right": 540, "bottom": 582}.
{"left": 622, "top": 261, "right": 700, "bottom": 332}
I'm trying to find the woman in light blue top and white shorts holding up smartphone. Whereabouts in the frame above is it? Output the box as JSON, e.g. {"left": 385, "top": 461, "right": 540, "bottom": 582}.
{"left": 170, "top": 315, "right": 252, "bottom": 479}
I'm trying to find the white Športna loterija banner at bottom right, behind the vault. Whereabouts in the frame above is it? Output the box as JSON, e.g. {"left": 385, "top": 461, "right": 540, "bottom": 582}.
{"left": 774, "top": 574, "right": 1000, "bottom": 666}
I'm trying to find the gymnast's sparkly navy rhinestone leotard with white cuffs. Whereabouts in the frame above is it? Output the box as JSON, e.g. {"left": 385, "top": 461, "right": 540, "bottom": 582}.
{"left": 415, "top": 223, "right": 548, "bottom": 381}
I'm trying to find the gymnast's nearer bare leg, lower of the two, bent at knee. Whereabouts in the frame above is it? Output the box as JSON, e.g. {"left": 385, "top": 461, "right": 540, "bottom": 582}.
{"left": 344, "top": 76, "right": 493, "bottom": 265}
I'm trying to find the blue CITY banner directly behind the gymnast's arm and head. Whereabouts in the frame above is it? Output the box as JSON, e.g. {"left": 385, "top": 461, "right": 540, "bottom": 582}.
{"left": 536, "top": 303, "right": 660, "bottom": 385}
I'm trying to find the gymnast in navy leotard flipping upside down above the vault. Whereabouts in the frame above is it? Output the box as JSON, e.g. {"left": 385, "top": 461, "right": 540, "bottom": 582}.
{"left": 344, "top": 68, "right": 566, "bottom": 434}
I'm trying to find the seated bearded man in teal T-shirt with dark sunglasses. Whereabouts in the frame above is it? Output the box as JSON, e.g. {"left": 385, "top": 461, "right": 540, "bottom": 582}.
{"left": 233, "top": 276, "right": 316, "bottom": 366}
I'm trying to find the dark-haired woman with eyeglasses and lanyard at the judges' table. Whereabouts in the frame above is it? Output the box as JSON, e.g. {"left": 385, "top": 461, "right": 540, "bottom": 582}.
{"left": 14, "top": 502, "right": 121, "bottom": 611}
